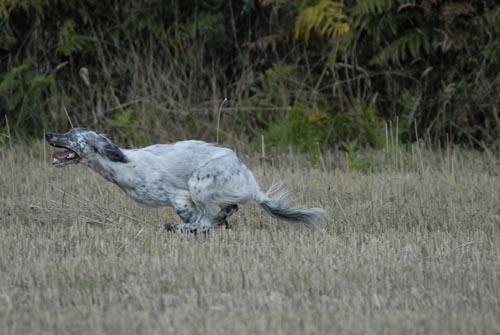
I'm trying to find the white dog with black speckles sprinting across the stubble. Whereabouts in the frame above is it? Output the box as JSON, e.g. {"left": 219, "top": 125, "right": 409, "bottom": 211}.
{"left": 46, "top": 128, "right": 325, "bottom": 231}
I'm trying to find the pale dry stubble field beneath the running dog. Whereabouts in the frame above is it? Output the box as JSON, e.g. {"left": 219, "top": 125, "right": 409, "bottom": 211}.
{"left": 0, "top": 144, "right": 500, "bottom": 335}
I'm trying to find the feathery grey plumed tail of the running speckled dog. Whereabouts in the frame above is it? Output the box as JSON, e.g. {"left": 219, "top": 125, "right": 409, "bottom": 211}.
{"left": 255, "top": 183, "right": 328, "bottom": 228}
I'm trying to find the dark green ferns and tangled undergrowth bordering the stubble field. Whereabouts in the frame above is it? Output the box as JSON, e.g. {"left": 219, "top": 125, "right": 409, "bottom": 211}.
{"left": 0, "top": 0, "right": 500, "bottom": 153}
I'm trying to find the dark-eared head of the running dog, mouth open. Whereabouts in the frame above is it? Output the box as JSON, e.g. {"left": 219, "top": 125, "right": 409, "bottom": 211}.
{"left": 45, "top": 128, "right": 127, "bottom": 166}
